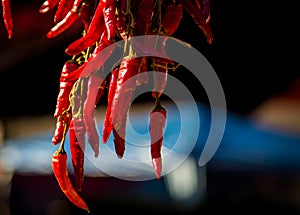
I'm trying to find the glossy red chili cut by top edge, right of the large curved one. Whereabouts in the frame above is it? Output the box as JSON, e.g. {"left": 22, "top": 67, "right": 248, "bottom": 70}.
{"left": 101, "top": 0, "right": 116, "bottom": 40}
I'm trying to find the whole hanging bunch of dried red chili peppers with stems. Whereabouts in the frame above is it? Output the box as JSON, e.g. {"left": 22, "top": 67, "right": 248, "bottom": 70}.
{"left": 2, "top": 0, "right": 213, "bottom": 211}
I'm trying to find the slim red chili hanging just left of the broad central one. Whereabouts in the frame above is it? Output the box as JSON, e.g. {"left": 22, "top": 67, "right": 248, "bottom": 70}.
{"left": 102, "top": 67, "right": 119, "bottom": 143}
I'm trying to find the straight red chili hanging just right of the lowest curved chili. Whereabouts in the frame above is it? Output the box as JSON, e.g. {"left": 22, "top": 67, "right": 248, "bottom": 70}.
{"left": 69, "top": 118, "right": 85, "bottom": 191}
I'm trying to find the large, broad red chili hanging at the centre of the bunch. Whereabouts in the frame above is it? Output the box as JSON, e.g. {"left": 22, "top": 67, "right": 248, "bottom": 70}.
{"left": 111, "top": 58, "right": 142, "bottom": 158}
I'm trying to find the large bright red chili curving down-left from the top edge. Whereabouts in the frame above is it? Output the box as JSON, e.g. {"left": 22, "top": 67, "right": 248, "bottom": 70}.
{"left": 65, "top": 1, "right": 105, "bottom": 55}
